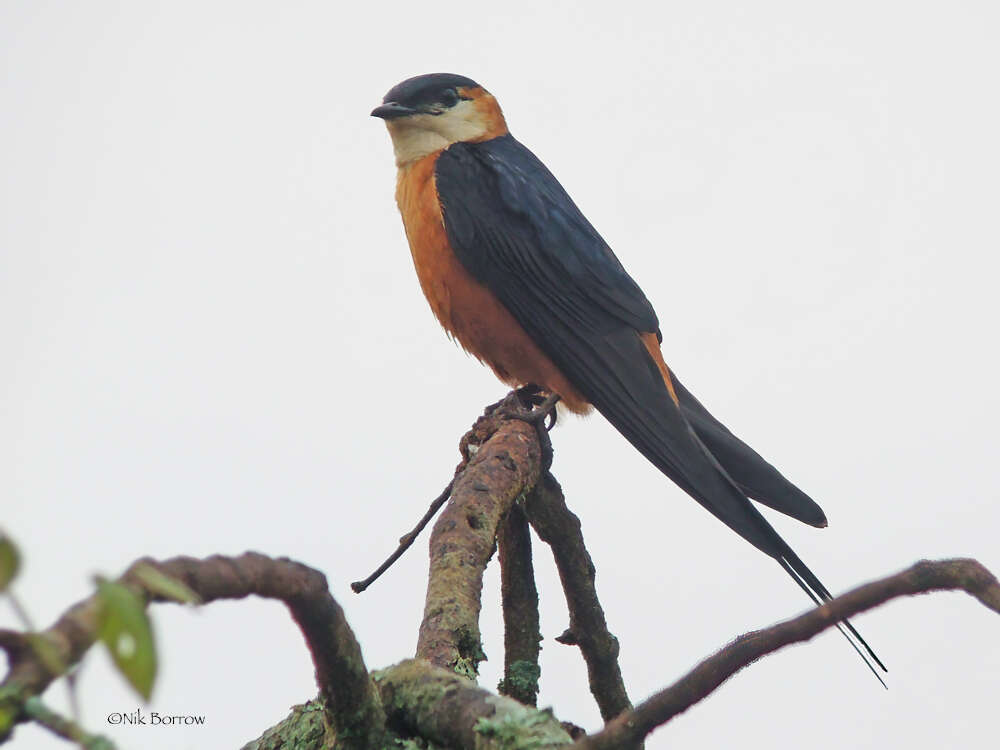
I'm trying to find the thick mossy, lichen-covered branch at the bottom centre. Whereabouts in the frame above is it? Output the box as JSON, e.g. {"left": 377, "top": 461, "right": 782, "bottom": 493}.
{"left": 373, "top": 659, "right": 572, "bottom": 750}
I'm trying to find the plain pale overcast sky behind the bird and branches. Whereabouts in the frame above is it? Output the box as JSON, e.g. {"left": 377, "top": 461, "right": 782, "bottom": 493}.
{"left": 0, "top": 0, "right": 1000, "bottom": 750}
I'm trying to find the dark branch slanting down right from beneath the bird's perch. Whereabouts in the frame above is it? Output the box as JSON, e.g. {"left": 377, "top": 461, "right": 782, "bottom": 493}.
{"left": 525, "top": 473, "right": 632, "bottom": 721}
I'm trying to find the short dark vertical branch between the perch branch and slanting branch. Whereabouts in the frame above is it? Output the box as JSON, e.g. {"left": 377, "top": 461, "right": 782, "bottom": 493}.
{"left": 497, "top": 505, "right": 542, "bottom": 706}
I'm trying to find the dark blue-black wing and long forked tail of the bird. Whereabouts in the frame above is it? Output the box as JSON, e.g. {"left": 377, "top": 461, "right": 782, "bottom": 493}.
{"left": 435, "top": 135, "right": 884, "bottom": 679}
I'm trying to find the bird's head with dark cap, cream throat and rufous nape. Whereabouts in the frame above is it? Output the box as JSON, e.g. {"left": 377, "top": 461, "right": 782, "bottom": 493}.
{"left": 372, "top": 73, "right": 507, "bottom": 167}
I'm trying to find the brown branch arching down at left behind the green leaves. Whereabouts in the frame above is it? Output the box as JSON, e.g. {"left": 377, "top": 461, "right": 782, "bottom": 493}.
{"left": 0, "top": 552, "right": 384, "bottom": 750}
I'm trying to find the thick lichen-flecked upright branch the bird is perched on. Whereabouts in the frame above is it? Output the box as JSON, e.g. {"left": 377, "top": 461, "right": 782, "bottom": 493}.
{"left": 417, "top": 409, "right": 541, "bottom": 677}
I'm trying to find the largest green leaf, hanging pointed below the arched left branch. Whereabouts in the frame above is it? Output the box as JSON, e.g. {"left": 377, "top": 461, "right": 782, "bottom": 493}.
{"left": 97, "top": 579, "right": 156, "bottom": 701}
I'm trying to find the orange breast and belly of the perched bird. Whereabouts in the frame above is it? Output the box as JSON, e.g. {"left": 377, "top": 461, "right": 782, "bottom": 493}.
{"left": 396, "top": 152, "right": 590, "bottom": 414}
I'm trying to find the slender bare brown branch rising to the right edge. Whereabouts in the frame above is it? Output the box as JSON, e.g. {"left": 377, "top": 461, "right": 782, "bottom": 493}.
{"left": 575, "top": 560, "right": 1000, "bottom": 750}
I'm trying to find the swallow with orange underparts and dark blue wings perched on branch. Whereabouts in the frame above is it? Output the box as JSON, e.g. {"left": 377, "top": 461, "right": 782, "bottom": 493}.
{"left": 371, "top": 73, "right": 887, "bottom": 685}
